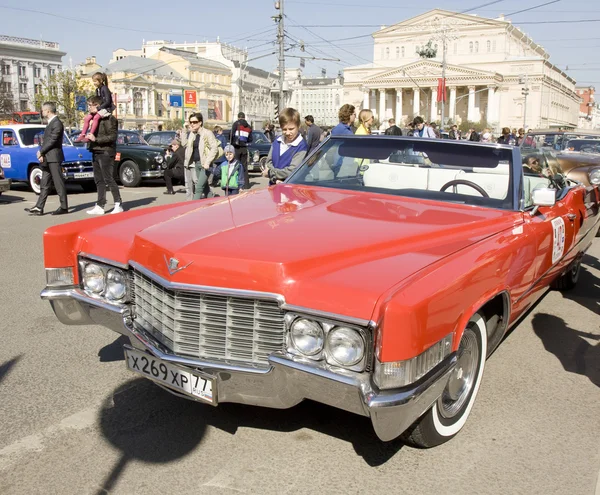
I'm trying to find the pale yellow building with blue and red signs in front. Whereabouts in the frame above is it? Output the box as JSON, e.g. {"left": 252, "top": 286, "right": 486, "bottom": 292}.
{"left": 80, "top": 48, "right": 232, "bottom": 131}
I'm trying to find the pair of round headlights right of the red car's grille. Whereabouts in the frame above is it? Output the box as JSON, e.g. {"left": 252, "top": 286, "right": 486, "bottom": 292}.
{"left": 289, "top": 318, "right": 366, "bottom": 368}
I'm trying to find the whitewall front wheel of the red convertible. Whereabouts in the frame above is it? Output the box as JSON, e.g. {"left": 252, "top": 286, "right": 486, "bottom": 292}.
{"left": 403, "top": 313, "right": 487, "bottom": 448}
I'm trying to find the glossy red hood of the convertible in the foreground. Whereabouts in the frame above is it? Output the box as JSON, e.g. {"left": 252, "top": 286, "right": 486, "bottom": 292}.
{"left": 80, "top": 184, "right": 518, "bottom": 320}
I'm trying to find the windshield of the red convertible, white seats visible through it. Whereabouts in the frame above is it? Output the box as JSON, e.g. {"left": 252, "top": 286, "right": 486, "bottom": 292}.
{"left": 287, "top": 136, "right": 515, "bottom": 209}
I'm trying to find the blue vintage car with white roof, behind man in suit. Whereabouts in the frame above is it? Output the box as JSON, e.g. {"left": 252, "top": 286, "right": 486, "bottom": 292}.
{"left": 0, "top": 124, "right": 95, "bottom": 194}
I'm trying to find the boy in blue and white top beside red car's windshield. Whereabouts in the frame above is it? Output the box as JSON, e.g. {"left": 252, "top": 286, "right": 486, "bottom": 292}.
{"left": 262, "top": 108, "right": 308, "bottom": 185}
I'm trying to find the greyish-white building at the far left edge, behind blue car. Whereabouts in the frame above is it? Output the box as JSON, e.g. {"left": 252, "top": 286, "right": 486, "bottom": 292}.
{"left": 0, "top": 35, "right": 66, "bottom": 111}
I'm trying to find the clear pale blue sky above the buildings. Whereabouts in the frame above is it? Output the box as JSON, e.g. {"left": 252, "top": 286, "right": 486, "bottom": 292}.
{"left": 0, "top": 0, "right": 600, "bottom": 90}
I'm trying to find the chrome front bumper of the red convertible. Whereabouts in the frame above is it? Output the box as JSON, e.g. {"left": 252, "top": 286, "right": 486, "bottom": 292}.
{"left": 41, "top": 288, "right": 456, "bottom": 441}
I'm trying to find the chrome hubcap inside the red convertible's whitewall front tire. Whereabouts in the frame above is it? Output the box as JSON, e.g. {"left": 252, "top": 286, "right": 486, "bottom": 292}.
{"left": 438, "top": 328, "right": 479, "bottom": 418}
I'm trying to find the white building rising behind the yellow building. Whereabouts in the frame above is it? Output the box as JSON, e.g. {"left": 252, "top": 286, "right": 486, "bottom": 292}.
{"left": 111, "top": 39, "right": 276, "bottom": 128}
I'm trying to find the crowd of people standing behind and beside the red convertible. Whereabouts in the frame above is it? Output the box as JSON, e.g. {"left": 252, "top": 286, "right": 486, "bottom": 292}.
{"left": 25, "top": 73, "right": 539, "bottom": 216}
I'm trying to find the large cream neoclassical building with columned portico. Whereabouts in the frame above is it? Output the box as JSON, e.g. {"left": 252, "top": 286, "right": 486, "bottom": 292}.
{"left": 344, "top": 9, "right": 580, "bottom": 130}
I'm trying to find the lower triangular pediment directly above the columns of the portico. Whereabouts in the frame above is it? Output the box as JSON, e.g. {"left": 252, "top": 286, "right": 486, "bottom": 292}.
{"left": 365, "top": 60, "right": 502, "bottom": 86}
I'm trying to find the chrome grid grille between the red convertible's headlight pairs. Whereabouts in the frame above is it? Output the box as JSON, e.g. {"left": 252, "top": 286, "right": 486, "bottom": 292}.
{"left": 133, "top": 270, "right": 285, "bottom": 367}
